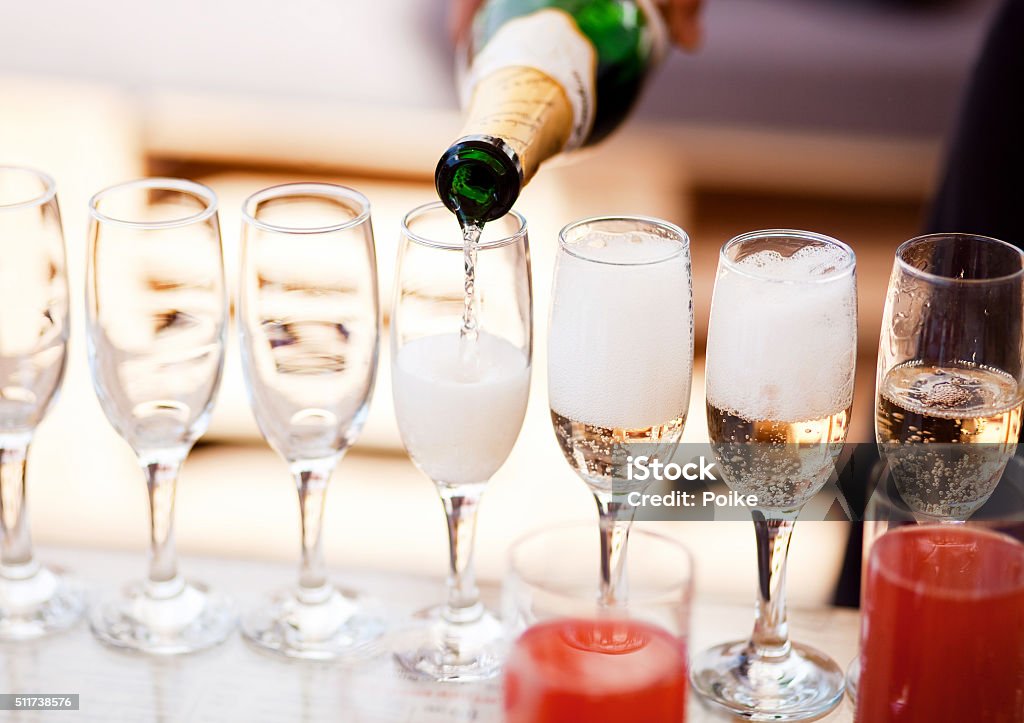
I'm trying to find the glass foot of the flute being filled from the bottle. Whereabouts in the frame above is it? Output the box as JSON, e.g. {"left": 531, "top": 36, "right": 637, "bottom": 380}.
{"left": 394, "top": 606, "right": 508, "bottom": 682}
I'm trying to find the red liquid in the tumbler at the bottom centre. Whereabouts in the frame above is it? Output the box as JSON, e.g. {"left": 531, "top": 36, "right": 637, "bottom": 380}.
{"left": 505, "top": 620, "right": 687, "bottom": 723}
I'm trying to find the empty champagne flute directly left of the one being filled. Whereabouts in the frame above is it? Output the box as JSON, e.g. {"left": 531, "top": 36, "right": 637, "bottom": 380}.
{"left": 239, "top": 183, "right": 383, "bottom": 661}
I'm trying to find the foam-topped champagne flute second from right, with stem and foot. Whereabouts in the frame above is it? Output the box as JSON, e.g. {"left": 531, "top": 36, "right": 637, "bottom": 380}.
{"left": 691, "top": 230, "right": 857, "bottom": 721}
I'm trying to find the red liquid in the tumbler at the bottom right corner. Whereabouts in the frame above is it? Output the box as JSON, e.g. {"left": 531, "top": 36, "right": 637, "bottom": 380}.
{"left": 856, "top": 525, "right": 1024, "bottom": 723}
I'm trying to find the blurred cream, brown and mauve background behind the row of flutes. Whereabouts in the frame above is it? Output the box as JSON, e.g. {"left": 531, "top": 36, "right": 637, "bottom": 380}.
{"left": 0, "top": 0, "right": 994, "bottom": 605}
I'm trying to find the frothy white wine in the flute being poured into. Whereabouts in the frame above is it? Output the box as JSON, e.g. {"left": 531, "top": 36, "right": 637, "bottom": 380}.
{"left": 392, "top": 332, "right": 530, "bottom": 485}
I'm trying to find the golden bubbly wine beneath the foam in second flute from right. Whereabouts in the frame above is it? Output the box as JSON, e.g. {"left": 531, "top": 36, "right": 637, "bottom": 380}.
{"left": 708, "top": 401, "right": 850, "bottom": 509}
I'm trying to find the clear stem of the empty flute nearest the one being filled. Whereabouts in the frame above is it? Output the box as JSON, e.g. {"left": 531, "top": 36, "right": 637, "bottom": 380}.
{"left": 292, "top": 457, "right": 338, "bottom": 605}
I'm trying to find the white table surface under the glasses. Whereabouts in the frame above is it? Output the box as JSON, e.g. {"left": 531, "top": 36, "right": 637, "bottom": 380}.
{"left": 0, "top": 549, "right": 857, "bottom": 723}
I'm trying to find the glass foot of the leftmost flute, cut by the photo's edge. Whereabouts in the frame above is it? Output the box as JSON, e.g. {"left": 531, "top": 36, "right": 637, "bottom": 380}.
{"left": 0, "top": 567, "right": 85, "bottom": 640}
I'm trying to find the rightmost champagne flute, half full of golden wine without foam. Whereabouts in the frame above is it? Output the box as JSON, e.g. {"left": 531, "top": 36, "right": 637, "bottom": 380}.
{"left": 874, "top": 233, "right": 1024, "bottom": 522}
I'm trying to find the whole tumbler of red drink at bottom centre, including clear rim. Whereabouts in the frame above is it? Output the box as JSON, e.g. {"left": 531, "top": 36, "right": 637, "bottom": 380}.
{"left": 503, "top": 523, "right": 692, "bottom": 723}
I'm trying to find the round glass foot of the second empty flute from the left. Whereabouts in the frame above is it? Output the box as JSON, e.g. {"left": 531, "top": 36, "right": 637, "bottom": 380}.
{"left": 90, "top": 581, "right": 238, "bottom": 655}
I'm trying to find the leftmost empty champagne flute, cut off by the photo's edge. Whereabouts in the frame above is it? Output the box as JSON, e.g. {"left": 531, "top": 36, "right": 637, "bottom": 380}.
{"left": 0, "top": 166, "right": 84, "bottom": 640}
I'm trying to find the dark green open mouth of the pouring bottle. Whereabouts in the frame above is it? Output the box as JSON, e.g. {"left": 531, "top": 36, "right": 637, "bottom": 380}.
{"left": 434, "top": 135, "right": 523, "bottom": 225}
